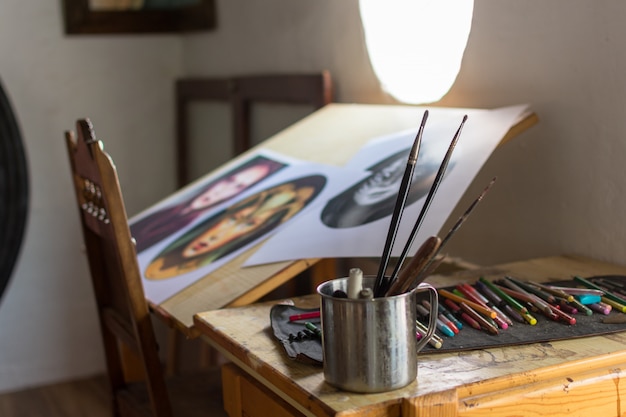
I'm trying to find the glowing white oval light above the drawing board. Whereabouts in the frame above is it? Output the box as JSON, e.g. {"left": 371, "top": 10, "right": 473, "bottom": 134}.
{"left": 360, "top": 0, "right": 474, "bottom": 104}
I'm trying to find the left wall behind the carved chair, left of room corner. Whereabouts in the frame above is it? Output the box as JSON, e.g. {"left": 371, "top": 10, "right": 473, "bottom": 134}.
{"left": 0, "top": 0, "right": 181, "bottom": 391}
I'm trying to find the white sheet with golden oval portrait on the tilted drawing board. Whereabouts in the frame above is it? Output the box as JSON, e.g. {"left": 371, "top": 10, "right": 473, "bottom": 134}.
{"left": 135, "top": 156, "right": 364, "bottom": 303}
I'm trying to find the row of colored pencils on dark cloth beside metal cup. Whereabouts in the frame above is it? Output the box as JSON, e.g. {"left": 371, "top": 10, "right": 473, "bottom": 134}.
{"left": 417, "top": 276, "right": 626, "bottom": 348}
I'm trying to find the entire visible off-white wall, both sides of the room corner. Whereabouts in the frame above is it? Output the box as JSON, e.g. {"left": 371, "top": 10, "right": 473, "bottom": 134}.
{"left": 0, "top": 0, "right": 626, "bottom": 390}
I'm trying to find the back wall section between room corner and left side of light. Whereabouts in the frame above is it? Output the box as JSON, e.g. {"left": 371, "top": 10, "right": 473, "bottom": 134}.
{"left": 184, "top": 0, "right": 390, "bottom": 103}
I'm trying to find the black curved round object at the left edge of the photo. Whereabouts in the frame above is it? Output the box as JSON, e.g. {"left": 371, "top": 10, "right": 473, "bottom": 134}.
{"left": 0, "top": 79, "right": 29, "bottom": 306}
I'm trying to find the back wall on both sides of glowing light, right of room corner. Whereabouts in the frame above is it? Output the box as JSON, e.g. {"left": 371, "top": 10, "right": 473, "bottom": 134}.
{"left": 184, "top": 0, "right": 626, "bottom": 263}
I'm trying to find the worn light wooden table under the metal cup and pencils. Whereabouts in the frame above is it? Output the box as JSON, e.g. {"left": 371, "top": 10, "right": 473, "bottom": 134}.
{"left": 194, "top": 256, "right": 626, "bottom": 417}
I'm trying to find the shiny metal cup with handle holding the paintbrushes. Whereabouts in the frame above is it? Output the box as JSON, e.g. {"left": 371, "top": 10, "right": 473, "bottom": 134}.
{"left": 317, "top": 276, "right": 438, "bottom": 392}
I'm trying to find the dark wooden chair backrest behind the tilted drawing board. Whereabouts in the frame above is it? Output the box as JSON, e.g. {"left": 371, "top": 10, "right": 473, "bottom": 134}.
{"left": 176, "top": 71, "right": 333, "bottom": 187}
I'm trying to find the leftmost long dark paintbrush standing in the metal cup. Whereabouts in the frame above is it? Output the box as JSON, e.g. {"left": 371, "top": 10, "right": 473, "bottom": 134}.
{"left": 374, "top": 110, "right": 428, "bottom": 297}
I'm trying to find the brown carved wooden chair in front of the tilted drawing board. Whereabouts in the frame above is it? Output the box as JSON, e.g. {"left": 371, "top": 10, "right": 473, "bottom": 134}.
{"left": 66, "top": 119, "right": 226, "bottom": 417}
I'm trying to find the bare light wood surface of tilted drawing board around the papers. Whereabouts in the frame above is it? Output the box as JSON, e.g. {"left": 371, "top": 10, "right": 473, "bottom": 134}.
{"left": 151, "top": 103, "right": 538, "bottom": 337}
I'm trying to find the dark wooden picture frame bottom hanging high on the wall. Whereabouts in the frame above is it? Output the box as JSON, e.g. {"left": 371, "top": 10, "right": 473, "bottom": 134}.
{"left": 63, "top": 0, "right": 216, "bottom": 35}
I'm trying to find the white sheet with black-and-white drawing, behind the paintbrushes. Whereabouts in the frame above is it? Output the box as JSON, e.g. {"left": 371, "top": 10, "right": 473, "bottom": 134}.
{"left": 246, "top": 105, "right": 527, "bottom": 266}
